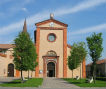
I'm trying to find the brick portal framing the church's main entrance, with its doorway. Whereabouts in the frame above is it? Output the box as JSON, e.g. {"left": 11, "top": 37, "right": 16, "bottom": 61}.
{"left": 43, "top": 56, "right": 59, "bottom": 78}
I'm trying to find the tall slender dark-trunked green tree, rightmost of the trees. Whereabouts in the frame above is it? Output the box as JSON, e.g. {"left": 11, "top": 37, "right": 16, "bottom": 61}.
{"left": 86, "top": 33, "right": 103, "bottom": 83}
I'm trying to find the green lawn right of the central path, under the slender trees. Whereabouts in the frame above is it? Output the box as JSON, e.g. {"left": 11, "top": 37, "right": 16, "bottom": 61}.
{"left": 64, "top": 78, "right": 106, "bottom": 87}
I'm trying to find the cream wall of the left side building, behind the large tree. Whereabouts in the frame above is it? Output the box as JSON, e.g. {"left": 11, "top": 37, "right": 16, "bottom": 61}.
{"left": 0, "top": 48, "right": 35, "bottom": 77}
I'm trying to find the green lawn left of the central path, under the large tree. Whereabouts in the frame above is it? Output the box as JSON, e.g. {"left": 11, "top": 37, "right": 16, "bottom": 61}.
{"left": 0, "top": 78, "right": 43, "bottom": 87}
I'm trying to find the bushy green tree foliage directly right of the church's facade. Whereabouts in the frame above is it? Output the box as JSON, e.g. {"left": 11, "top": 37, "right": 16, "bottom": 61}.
{"left": 68, "top": 42, "right": 87, "bottom": 77}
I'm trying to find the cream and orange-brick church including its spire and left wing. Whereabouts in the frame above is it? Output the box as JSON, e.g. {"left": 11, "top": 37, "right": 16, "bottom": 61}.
{"left": 0, "top": 14, "right": 86, "bottom": 78}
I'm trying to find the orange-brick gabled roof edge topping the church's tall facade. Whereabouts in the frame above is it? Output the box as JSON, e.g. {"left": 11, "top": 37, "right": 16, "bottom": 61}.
{"left": 35, "top": 18, "right": 68, "bottom": 27}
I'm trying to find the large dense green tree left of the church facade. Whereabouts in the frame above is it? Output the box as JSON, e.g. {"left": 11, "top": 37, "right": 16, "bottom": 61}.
{"left": 13, "top": 32, "right": 37, "bottom": 81}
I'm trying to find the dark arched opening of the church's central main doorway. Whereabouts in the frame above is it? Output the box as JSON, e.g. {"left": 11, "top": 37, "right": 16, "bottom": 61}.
{"left": 47, "top": 62, "right": 55, "bottom": 77}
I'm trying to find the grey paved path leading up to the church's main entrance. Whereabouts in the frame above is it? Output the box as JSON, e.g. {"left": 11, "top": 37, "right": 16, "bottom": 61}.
{"left": 39, "top": 78, "right": 79, "bottom": 88}
